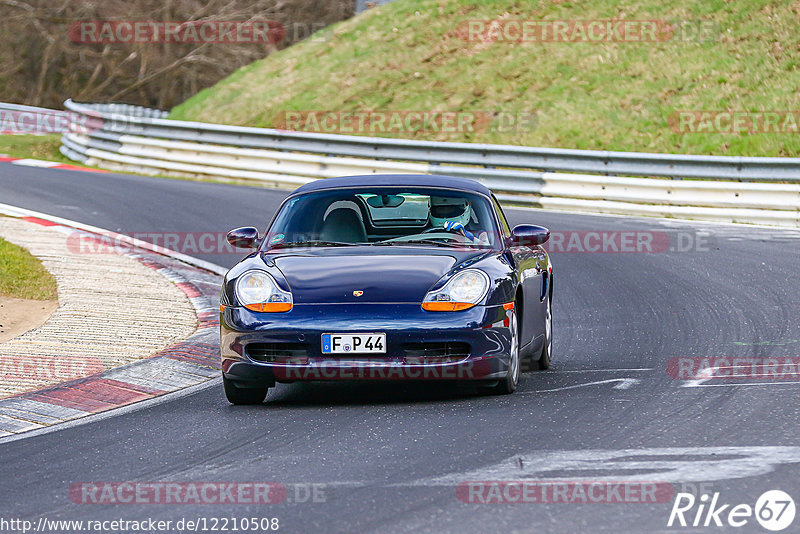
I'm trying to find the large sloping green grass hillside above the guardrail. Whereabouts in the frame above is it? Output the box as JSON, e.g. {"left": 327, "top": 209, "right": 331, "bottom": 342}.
{"left": 170, "top": 0, "right": 800, "bottom": 156}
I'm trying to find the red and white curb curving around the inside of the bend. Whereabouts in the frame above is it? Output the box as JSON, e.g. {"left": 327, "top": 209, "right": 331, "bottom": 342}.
{"left": 0, "top": 204, "right": 225, "bottom": 442}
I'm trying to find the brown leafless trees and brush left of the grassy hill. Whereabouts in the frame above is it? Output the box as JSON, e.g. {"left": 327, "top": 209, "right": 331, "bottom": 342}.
{"left": 0, "top": 0, "right": 354, "bottom": 109}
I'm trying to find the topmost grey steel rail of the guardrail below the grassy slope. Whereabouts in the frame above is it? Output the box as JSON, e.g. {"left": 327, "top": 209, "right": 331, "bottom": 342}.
{"left": 65, "top": 100, "right": 800, "bottom": 182}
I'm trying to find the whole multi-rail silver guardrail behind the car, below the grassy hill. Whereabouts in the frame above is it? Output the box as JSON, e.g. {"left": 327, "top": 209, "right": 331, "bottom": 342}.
{"left": 56, "top": 100, "right": 800, "bottom": 227}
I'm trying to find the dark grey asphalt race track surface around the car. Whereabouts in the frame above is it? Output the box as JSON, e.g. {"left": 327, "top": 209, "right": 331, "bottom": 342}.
{"left": 0, "top": 164, "right": 800, "bottom": 532}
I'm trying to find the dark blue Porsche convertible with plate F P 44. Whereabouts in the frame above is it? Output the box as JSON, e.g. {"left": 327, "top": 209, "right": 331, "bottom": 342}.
{"left": 220, "top": 175, "right": 553, "bottom": 404}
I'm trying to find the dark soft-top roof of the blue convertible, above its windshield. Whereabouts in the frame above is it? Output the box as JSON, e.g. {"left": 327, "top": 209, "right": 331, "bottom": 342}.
{"left": 293, "top": 174, "right": 491, "bottom": 196}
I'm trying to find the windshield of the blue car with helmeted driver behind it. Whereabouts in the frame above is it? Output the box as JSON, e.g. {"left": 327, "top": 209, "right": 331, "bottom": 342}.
{"left": 264, "top": 187, "right": 499, "bottom": 249}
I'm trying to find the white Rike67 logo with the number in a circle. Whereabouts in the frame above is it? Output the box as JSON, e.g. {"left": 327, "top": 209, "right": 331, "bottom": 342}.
{"left": 667, "top": 490, "right": 795, "bottom": 532}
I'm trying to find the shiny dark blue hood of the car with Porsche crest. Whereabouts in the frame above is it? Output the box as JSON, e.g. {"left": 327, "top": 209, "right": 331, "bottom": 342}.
{"left": 265, "top": 247, "right": 487, "bottom": 304}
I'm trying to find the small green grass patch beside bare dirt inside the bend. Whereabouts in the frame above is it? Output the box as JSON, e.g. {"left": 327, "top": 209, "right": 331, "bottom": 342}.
{"left": 0, "top": 239, "right": 58, "bottom": 300}
